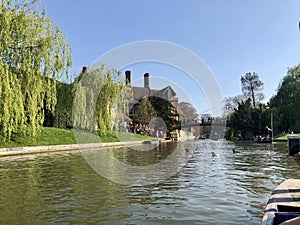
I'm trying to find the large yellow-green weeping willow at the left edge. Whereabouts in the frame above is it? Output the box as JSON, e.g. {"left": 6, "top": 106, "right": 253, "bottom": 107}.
{"left": 0, "top": 0, "right": 71, "bottom": 141}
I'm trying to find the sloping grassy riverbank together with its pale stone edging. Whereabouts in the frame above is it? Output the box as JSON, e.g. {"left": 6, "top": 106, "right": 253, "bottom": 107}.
{"left": 0, "top": 127, "right": 153, "bottom": 157}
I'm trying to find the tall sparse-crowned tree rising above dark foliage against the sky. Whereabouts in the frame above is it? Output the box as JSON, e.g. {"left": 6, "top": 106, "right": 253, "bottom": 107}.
{"left": 241, "top": 73, "right": 264, "bottom": 108}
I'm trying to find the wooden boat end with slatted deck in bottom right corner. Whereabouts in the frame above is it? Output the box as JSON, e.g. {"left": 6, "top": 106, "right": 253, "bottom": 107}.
{"left": 261, "top": 179, "right": 300, "bottom": 225}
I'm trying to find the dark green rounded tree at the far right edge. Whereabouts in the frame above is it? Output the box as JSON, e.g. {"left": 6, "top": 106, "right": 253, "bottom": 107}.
{"left": 270, "top": 65, "right": 300, "bottom": 132}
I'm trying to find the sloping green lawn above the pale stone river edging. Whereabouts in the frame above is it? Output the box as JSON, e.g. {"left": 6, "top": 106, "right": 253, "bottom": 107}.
{"left": 0, "top": 127, "right": 151, "bottom": 148}
